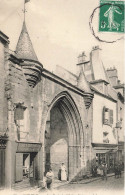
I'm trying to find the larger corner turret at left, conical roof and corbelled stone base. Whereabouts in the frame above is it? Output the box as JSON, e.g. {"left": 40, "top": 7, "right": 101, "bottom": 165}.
{"left": 16, "top": 21, "right": 43, "bottom": 87}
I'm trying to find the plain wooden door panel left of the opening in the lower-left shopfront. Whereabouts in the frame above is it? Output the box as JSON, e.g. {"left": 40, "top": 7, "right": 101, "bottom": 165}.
{"left": 16, "top": 153, "right": 23, "bottom": 182}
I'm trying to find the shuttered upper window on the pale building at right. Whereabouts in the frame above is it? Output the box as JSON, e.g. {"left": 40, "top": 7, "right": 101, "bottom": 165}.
{"left": 103, "top": 106, "right": 113, "bottom": 125}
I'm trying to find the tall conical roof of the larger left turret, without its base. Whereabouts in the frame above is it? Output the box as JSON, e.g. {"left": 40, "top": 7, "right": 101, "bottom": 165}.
{"left": 16, "top": 21, "right": 38, "bottom": 61}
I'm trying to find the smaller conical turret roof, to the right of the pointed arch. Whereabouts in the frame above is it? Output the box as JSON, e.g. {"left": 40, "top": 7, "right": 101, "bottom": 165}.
{"left": 77, "top": 67, "right": 91, "bottom": 93}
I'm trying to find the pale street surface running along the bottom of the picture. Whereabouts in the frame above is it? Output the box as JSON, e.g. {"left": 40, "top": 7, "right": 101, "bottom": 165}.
{"left": 0, "top": 174, "right": 124, "bottom": 195}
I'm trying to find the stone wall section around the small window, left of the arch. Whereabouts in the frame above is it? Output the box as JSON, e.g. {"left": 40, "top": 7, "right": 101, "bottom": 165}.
{"left": 6, "top": 58, "right": 41, "bottom": 142}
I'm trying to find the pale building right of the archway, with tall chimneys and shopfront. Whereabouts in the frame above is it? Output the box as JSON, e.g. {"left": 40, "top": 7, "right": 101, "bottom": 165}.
{"left": 77, "top": 46, "right": 124, "bottom": 171}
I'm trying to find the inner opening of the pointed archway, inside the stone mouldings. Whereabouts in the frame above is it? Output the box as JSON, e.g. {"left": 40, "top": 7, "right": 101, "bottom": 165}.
{"left": 45, "top": 105, "right": 68, "bottom": 178}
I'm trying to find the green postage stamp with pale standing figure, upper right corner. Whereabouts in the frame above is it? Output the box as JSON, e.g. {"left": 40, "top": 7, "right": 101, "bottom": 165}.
{"left": 99, "top": 0, "right": 125, "bottom": 33}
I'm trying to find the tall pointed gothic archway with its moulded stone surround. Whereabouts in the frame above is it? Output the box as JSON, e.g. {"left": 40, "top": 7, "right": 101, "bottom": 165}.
{"left": 44, "top": 92, "right": 83, "bottom": 180}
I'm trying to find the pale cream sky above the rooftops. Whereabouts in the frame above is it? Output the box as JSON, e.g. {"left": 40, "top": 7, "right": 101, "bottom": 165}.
{"left": 0, "top": 0, "right": 125, "bottom": 82}
